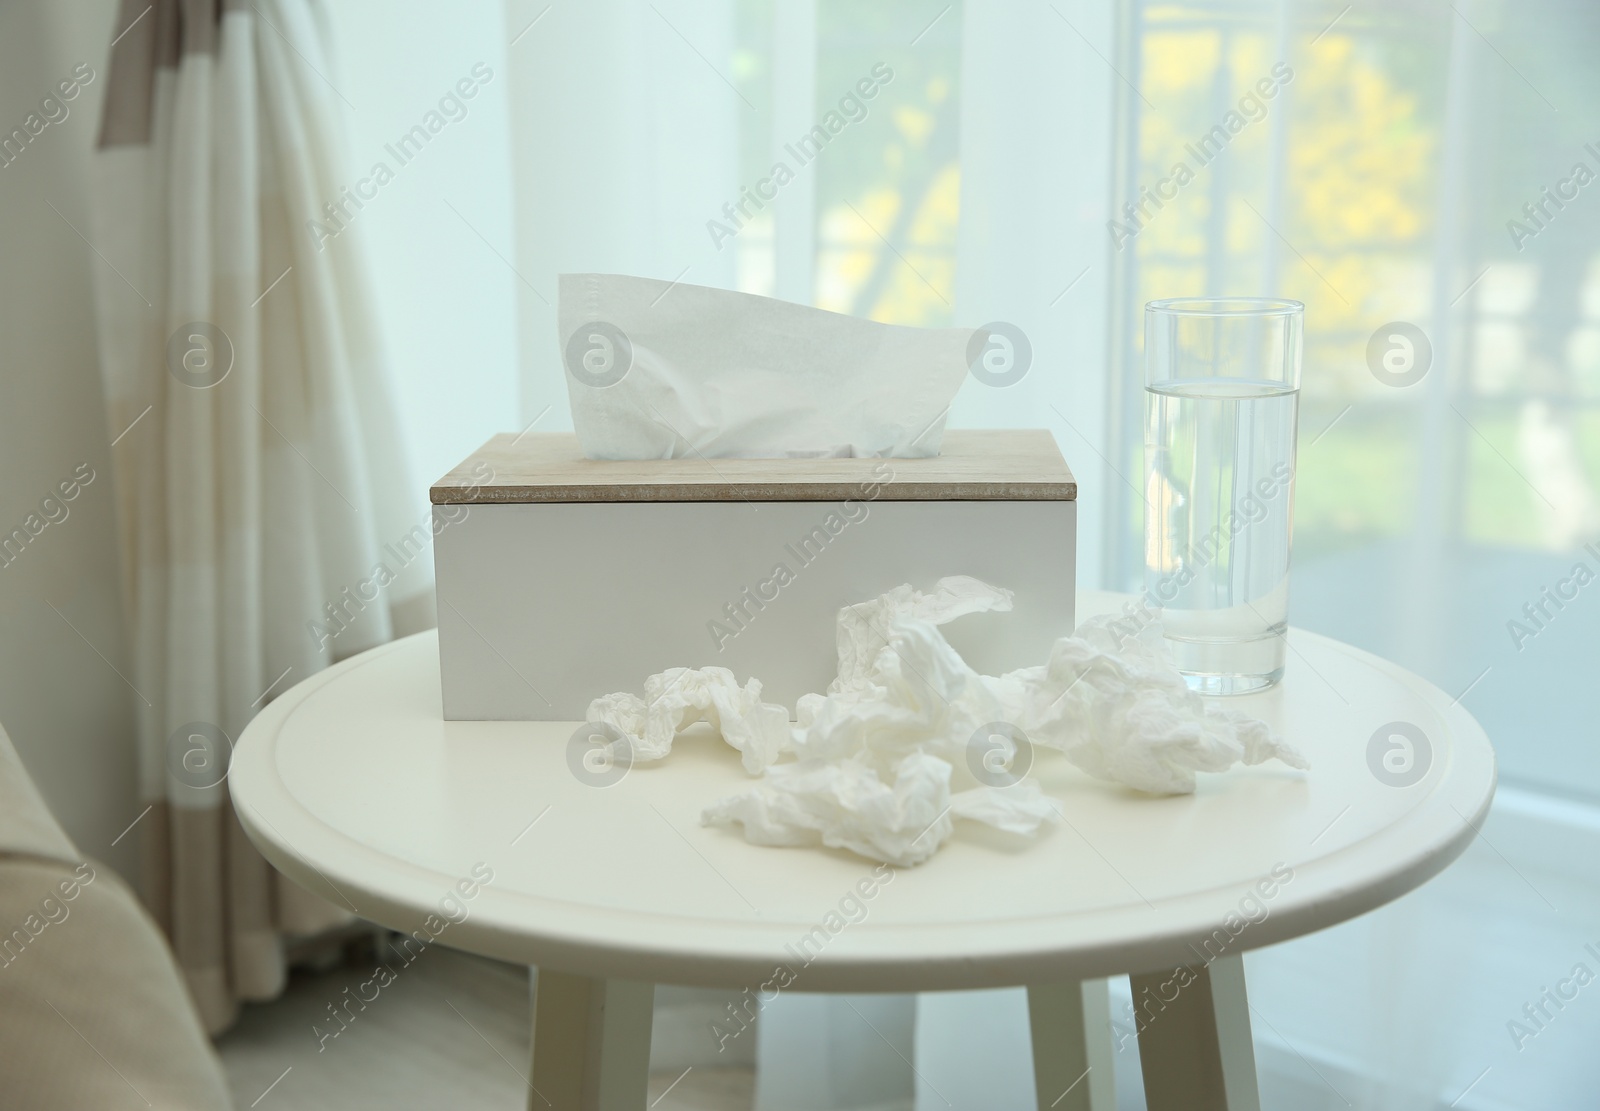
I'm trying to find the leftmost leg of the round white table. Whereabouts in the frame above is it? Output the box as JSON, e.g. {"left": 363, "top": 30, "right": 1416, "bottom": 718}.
{"left": 528, "top": 969, "right": 656, "bottom": 1111}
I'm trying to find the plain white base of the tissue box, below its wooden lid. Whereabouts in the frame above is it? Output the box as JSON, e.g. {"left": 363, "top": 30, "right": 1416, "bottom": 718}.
{"left": 434, "top": 499, "right": 1077, "bottom": 720}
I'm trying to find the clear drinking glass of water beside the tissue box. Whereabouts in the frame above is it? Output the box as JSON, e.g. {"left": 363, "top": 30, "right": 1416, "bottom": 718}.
{"left": 1144, "top": 298, "right": 1306, "bottom": 695}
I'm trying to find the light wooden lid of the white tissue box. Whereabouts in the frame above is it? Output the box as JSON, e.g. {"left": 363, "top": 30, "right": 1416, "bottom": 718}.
{"left": 429, "top": 429, "right": 1078, "bottom": 506}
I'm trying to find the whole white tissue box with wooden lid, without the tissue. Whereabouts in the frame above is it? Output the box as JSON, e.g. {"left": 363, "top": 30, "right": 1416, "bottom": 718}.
{"left": 430, "top": 429, "right": 1077, "bottom": 720}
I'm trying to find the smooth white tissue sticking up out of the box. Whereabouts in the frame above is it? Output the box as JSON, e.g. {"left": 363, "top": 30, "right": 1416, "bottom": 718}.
{"left": 557, "top": 274, "right": 974, "bottom": 459}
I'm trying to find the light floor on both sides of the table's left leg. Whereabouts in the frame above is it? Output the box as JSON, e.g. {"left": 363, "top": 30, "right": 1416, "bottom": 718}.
{"left": 218, "top": 946, "right": 755, "bottom": 1111}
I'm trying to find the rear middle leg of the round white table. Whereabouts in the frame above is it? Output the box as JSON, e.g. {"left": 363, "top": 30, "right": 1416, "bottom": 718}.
{"left": 1027, "top": 980, "right": 1117, "bottom": 1111}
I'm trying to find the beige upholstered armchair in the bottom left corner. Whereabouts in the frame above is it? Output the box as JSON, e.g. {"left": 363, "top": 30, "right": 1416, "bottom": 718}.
{"left": 0, "top": 728, "right": 234, "bottom": 1111}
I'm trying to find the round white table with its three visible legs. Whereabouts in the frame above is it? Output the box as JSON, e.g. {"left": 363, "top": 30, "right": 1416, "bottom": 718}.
{"left": 229, "top": 594, "right": 1494, "bottom": 1111}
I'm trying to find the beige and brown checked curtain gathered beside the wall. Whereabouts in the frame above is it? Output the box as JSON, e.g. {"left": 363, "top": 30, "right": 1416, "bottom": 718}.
{"left": 81, "top": 0, "right": 430, "bottom": 1033}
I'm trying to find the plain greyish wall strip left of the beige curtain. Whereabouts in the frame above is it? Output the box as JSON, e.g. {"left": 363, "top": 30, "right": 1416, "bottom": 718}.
{"left": 0, "top": 0, "right": 141, "bottom": 880}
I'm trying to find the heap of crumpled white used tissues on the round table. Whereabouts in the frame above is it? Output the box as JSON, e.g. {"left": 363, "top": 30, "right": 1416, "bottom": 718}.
{"left": 589, "top": 576, "right": 1307, "bottom": 866}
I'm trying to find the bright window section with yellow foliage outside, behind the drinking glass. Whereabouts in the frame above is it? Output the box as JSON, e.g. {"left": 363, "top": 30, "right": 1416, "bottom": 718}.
{"left": 1107, "top": 0, "right": 1600, "bottom": 810}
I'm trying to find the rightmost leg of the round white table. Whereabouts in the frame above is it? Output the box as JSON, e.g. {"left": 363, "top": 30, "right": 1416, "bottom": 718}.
{"left": 1130, "top": 954, "right": 1261, "bottom": 1111}
